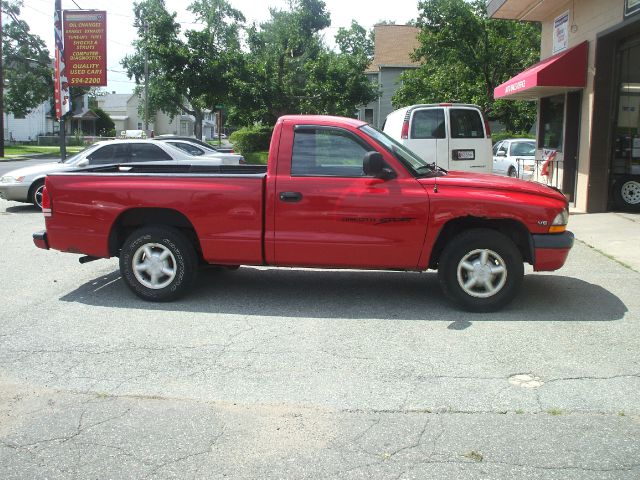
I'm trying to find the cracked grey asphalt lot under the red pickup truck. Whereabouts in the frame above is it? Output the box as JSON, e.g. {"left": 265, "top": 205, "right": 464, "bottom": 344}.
{"left": 0, "top": 200, "right": 640, "bottom": 480}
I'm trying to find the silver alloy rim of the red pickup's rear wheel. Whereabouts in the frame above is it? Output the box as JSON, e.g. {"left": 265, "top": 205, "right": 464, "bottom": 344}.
{"left": 131, "top": 243, "right": 177, "bottom": 290}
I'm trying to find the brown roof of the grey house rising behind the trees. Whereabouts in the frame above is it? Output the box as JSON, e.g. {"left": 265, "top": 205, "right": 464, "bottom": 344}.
{"left": 367, "top": 25, "right": 420, "bottom": 72}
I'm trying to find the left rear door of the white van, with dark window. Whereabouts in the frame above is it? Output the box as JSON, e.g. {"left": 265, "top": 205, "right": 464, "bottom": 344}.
{"left": 405, "top": 107, "right": 449, "bottom": 169}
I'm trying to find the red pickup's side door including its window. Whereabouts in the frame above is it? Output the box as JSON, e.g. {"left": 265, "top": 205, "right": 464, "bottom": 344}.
{"left": 274, "top": 126, "right": 428, "bottom": 269}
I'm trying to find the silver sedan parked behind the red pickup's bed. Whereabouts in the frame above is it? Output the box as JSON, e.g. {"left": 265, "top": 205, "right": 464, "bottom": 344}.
{"left": 0, "top": 139, "right": 242, "bottom": 208}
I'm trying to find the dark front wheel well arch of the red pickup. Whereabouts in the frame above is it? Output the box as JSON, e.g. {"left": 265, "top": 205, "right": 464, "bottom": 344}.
{"left": 429, "top": 217, "right": 533, "bottom": 269}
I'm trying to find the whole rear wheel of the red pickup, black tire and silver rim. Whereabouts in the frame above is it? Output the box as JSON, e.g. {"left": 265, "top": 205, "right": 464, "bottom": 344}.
{"left": 120, "top": 226, "right": 198, "bottom": 302}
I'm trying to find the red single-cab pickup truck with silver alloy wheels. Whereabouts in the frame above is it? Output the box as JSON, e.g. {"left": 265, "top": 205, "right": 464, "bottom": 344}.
{"left": 34, "top": 115, "right": 573, "bottom": 311}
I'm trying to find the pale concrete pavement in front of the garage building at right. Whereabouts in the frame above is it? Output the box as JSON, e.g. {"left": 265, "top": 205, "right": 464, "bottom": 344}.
{"left": 568, "top": 212, "right": 640, "bottom": 272}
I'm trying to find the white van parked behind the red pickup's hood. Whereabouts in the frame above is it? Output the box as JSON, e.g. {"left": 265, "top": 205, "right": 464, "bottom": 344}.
{"left": 382, "top": 103, "right": 493, "bottom": 173}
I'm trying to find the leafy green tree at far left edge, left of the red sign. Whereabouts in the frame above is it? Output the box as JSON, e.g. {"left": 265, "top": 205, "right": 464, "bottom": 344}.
{"left": 2, "top": 1, "right": 53, "bottom": 116}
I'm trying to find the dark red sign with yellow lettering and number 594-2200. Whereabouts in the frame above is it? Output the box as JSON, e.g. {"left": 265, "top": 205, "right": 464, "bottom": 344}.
{"left": 64, "top": 10, "right": 107, "bottom": 87}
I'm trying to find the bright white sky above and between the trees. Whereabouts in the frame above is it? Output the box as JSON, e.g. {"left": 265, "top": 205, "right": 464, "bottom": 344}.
{"left": 21, "top": 0, "right": 418, "bottom": 93}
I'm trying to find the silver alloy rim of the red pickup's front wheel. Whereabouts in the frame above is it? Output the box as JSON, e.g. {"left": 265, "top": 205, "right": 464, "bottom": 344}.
{"left": 458, "top": 249, "right": 507, "bottom": 298}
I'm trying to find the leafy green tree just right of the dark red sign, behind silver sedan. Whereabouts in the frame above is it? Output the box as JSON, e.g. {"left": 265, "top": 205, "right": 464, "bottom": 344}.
{"left": 122, "top": 0, "right": 244, "bottom": 138}
